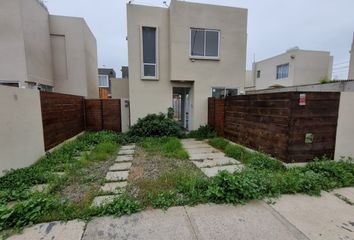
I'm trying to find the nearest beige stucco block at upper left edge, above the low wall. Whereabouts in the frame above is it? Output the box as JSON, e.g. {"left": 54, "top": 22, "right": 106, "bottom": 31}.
{"left": 0, "top": 0, "right": 53, "bottom": 86}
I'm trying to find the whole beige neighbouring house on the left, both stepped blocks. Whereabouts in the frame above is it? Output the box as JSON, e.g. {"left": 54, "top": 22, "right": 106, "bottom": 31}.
{"left": 0, "top": 0, "right": 98, "bottom": 98}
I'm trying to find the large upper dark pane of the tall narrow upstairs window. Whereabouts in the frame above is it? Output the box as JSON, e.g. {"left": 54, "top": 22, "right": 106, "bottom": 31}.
{"left": 143, "top": 27, "right": 156, "bottom": 63}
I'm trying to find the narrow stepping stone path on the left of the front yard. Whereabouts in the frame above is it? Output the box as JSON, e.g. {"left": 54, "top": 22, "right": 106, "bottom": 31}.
{"left": 91, "top": 144, "right": 135, "bottom": 207}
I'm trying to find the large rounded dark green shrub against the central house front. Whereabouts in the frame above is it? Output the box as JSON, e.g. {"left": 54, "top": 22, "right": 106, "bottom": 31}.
{"left": 129, "top": 113, "right": 182, "bottom": 137}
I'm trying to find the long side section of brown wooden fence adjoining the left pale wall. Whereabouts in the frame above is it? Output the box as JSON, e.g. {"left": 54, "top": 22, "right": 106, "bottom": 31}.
{"left": 40, "top": 92, "right": 85, "bottom": 151}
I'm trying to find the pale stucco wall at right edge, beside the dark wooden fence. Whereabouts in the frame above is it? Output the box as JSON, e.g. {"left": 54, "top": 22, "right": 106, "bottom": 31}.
{"left": 335, "top": 92, "right": 354, "bottom": 159}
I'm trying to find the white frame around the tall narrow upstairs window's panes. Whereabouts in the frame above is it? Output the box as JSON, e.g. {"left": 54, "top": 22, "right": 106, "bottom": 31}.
{"left": 140, "top": 25, "right": 159, "bottom": 80}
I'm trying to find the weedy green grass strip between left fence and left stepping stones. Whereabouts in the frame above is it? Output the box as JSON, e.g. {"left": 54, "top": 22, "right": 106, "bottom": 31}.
{"left": 0, "top": 132, "right": 122, "bottom": 231}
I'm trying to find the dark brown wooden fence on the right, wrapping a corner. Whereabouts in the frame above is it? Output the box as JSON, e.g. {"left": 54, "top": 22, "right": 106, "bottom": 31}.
{"left": 209, "top": 92, "right": 340, "bottom": 163}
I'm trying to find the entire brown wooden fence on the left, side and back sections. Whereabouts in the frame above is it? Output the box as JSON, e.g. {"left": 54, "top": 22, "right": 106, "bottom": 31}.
{"left": 40, "top": 92, "right": 121, "bottom": 151}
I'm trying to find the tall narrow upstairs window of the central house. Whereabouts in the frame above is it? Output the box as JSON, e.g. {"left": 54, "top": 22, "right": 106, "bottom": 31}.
{"left": 142, "top": 27, "right": 157, "bottom": 79}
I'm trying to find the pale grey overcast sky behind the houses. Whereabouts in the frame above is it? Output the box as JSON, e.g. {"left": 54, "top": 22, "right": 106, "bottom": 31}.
{"left": 45, "top": 0, "right": 354, "bottom": 79}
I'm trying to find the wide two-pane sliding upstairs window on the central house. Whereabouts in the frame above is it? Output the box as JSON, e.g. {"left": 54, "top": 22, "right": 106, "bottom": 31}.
{"left": 190, "top": 28, "right": 220, "bottom": 58}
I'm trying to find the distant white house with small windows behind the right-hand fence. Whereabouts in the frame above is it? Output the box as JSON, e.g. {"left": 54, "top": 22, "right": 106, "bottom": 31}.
{"left": 246, "top": 48, "right": 333, "bottom": 90}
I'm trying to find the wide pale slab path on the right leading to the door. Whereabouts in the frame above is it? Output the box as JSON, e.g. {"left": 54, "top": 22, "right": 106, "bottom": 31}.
{"left": 182, "top": 139, "right": 243, "bottom": 177}
